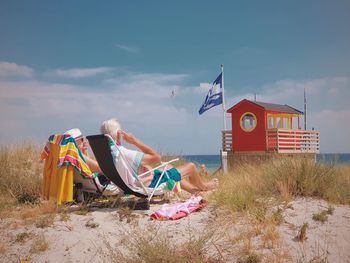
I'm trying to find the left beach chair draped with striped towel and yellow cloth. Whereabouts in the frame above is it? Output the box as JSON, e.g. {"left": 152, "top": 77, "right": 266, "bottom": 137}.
{"left": 41, "top": 134, "right": 117, "bottom": 205}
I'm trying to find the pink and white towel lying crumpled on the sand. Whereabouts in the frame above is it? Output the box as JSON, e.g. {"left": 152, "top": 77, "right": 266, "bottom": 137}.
{"left": 151, "top": 196, "right": 208, "bottom": 220}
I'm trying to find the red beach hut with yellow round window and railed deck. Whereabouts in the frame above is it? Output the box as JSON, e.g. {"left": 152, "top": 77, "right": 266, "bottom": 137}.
{"left": 222, "top": 99, "right": 319, "bottom": 164}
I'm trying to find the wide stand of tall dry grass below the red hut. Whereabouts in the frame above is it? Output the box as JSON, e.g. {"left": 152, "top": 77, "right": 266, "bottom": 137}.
{"left": 212, "top": 157, "right": 350, "bottom": 214}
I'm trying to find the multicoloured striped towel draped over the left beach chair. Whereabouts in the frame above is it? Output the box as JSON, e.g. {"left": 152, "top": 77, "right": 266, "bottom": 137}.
{"left": 41, "top": 134, "right": 94, "bottom": 178}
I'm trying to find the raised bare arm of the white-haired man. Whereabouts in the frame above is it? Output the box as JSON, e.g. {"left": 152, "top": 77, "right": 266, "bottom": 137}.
{"left": 119, "top": 131, "right": 161, "bottom": 165}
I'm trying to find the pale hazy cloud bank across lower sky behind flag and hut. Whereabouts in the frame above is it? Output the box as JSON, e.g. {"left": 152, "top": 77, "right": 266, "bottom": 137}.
{"left": 0, "top": 62, "right": 350, "bottom": 154}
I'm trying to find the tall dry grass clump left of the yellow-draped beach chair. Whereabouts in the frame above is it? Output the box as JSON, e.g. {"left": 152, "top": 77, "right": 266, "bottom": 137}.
{"left": 0, "top": 142, "right": 48, "bottom": 219}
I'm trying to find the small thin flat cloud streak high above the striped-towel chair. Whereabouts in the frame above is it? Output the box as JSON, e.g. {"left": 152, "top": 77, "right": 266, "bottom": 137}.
{"left": 53, "top": 67, "right": 113, "bottom": 78}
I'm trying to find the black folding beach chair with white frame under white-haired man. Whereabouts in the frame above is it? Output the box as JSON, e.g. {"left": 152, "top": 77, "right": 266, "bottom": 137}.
{"left": 86, "top": 134, "right": 179, "bottom": 201}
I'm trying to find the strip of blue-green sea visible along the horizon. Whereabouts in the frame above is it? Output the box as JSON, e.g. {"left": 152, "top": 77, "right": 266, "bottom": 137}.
{"left": 182, "top": 153, "right": 350, "bottom": 173}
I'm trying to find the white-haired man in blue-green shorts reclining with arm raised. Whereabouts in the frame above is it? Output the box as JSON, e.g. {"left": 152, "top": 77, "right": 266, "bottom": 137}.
{"left": 101, "top": 118, "right": 218, "bottom": 193}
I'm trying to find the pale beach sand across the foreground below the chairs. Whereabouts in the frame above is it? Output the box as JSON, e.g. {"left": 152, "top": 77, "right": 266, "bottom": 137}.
{"left": 0, "top": 198, "right": 350, "bottom": 262}
